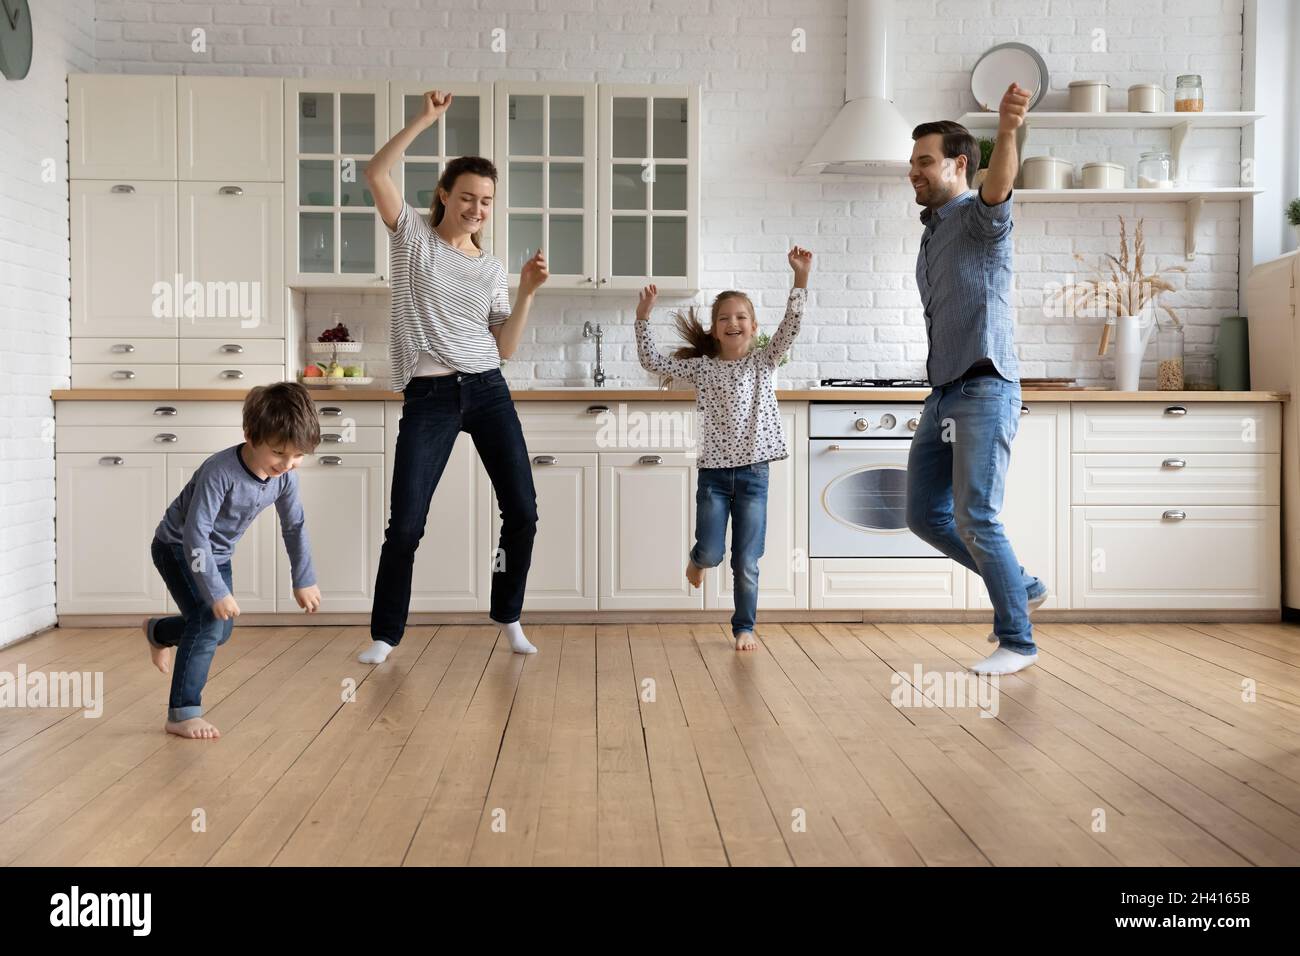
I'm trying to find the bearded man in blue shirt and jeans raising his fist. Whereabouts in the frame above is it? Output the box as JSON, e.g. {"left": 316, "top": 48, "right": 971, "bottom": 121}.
{"left": 907, "top": 83, "right": 1048, "bottom": 674}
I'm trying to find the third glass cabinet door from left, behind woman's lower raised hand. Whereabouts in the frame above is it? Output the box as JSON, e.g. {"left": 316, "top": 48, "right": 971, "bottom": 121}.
{"left": 493, "top": 83, "right": 598, "bottom": 290}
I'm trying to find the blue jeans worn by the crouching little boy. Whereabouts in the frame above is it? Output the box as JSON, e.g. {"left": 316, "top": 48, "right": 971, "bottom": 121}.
{"left": 148, "top": 538, "right": 235, "bottom": 721}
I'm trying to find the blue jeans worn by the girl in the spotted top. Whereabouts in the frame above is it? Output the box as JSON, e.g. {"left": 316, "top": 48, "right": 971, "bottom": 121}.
{"left": 690, "top": 462, "right": 767, "bottom": 633}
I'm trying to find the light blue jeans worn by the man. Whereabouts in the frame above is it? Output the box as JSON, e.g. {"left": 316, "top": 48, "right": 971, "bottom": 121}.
{"left": 907, "top": 375, "right": 1047, "bottom": 654}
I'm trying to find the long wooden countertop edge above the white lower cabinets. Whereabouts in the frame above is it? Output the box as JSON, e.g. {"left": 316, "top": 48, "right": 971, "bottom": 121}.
{"left": 49, "top": 388, "right": 1291, "bottom": 402}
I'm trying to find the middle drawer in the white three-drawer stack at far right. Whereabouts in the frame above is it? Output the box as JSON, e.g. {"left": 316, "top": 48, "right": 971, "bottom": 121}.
{"left": 1071, "top": 453, "right": 1282, "bottom": 507}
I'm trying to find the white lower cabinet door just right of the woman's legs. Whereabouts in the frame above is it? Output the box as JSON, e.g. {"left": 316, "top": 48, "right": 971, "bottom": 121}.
{"left": 491, "top": 451, "right": 599, "bottom": 611}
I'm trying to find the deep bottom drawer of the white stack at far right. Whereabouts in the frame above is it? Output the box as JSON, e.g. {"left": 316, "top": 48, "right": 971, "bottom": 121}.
{"left": 1070, "top": 505, "right": 1281, "bottom": 609}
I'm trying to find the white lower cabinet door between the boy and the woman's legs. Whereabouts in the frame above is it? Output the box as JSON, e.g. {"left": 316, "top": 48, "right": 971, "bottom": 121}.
{"left": 276, "top": 449, "right": 385, "bottom": 611}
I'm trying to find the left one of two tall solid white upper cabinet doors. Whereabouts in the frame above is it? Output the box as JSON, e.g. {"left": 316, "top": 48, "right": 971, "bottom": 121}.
{"left": 69, "top": 179, "right": 183, "bottom": 338}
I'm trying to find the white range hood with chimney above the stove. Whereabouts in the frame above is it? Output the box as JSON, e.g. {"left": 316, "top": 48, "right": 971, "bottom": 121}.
{"left": 796, "top": 0, "right": 915, "bottom": 179}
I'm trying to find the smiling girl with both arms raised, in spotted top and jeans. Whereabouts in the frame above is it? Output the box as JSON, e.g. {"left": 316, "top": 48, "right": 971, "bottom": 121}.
{"left": 636, "top": 246, "right": 813, "bottom": 650}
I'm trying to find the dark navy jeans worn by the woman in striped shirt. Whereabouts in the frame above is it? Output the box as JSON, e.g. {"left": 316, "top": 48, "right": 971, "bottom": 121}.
{"left": 371, "top": 368, "right": 537, "bottom": 645}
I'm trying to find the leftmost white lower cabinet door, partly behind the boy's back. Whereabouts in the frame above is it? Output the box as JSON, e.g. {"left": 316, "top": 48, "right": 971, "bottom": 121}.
{"left": 55, "top": 451, "right": 168, "bottom": 614}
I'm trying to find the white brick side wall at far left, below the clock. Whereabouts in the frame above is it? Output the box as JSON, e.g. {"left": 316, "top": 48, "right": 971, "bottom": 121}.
{"left": 0, "top": 0, "right": 94, "bottom": 645}
